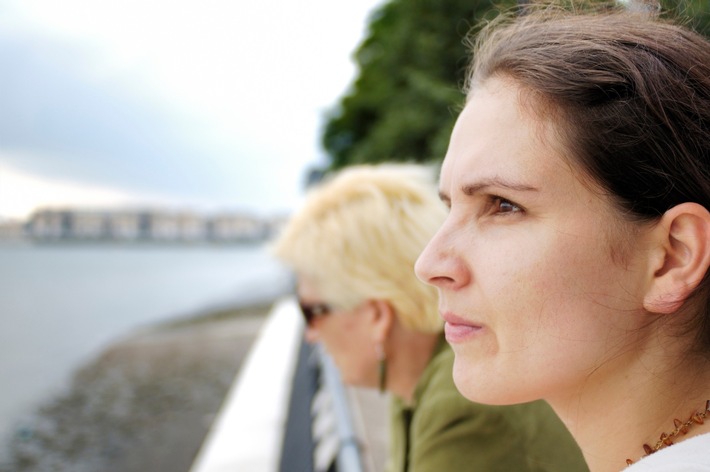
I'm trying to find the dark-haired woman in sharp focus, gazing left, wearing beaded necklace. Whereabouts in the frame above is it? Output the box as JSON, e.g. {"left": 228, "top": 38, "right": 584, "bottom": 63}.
{"left": 416, "top": 3, "right": 710, "bottom": 472}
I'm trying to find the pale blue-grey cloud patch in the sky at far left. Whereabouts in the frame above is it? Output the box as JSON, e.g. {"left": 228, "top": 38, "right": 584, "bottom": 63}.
{"left": 0, "top": 32, "right": 239, "bottom": 191}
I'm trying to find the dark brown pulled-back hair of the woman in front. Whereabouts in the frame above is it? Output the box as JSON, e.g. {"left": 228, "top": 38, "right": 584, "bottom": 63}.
{"left": 467, "top": 3, "right": 710, "bottom": 352}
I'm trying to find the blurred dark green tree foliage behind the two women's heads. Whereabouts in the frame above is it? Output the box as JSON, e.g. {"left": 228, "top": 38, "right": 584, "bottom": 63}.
{"left": 322, "top": 0, "right": 710, "bottom": 170}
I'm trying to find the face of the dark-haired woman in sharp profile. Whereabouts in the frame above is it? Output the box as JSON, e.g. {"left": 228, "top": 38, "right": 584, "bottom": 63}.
{"left": 416, "top": 79, "right": 656, "bottom": 404}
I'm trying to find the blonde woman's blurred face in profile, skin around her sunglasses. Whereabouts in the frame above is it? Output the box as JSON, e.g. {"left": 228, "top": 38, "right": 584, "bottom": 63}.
{"left": 298, "top": 277, "right": 378, "bottom": 387}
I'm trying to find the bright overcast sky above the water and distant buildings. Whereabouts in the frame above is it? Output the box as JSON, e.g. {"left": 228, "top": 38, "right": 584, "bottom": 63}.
{"left": 0, "top": 0, "right": 383, "bottom": 217}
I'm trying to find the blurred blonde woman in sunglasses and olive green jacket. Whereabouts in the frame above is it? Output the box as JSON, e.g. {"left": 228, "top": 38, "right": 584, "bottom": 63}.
{"left": 273, "top": 164, "right": 586, "bottom": 472}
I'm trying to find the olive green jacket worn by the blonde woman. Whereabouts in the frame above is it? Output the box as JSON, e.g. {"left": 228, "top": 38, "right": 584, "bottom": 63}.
{"left": 387, "top": 337, "right": 588, "bottom": 472}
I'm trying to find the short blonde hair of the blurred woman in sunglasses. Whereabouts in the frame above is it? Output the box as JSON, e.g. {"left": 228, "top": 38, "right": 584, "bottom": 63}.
{"left": 271, "top": 164, "right": 446, "bottom": 333}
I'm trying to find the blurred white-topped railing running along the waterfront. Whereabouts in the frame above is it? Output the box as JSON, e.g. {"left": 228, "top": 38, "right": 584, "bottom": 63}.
{"left": 190, "top": 298, "right": 364, "bottom": 472}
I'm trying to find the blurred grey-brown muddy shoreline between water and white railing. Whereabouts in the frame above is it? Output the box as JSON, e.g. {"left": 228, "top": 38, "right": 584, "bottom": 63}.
{"left": 0, "top": 302, "right": 272, "bottom": 472}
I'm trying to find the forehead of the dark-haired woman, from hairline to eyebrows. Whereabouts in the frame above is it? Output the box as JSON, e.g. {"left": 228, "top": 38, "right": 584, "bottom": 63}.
{"left": 439, "top": 83, "right": 603, "bottom": 210}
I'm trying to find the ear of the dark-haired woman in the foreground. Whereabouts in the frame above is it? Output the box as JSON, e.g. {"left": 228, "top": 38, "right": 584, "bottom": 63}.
{"left": 644, "top": 203, "right": 710, "bottom": 314}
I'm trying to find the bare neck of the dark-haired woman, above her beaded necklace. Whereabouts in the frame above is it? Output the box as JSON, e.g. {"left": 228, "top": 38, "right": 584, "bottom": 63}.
{"left": 548, "top": 348, "right": 710, "bottom": 472}
